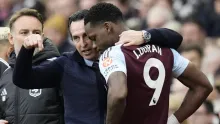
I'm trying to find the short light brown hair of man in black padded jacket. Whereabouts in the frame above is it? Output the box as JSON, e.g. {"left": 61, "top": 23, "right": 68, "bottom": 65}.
{"left": 9, "top": 8, "right": 44, "bottom": 30}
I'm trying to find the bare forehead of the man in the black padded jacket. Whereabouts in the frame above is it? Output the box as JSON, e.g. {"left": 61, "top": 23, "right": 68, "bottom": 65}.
{"left": 13, "top": 16, "right": 42, "bottom": 30}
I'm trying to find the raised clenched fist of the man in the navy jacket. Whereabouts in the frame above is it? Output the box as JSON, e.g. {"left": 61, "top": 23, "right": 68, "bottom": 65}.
{"left": 23, "top": 34, "right": 44, "bottom": 51}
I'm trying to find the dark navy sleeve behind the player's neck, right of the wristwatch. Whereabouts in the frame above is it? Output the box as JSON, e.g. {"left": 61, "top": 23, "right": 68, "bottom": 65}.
{"left": 146, "top": 28, "right": 183, "bottom": 49}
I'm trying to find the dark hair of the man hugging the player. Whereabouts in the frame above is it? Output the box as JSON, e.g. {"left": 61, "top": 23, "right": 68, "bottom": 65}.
{"left": 68, "top": 9, "right": 89, "bottom": 28}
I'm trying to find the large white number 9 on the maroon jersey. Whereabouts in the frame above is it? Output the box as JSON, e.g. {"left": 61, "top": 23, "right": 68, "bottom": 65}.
{"left": 143, "top": 58, "right": 165, "bottom": 106}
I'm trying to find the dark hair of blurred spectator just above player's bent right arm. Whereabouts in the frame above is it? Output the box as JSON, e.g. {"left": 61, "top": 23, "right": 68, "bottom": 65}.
{"left": 180, "top": 44, "right": 204, "bottom": 58}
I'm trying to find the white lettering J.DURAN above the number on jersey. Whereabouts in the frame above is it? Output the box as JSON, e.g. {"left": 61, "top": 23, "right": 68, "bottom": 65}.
{"left": 133, "top": 45, "right": 162, "bottom": 59}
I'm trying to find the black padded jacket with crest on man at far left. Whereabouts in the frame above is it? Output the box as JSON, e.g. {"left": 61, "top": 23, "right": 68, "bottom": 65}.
{"left": 0, "top": 39, "right": 64, "bottom": 124}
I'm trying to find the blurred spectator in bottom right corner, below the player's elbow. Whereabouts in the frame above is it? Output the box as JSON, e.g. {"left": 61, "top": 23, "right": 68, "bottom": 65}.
{"left": 188, "top": 101, "right": 219, "bottom": 124}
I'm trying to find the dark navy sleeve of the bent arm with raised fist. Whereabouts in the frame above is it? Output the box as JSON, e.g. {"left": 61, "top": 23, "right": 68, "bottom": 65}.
{"left": 13, "top": 46, "right": 63, "bottom": 89}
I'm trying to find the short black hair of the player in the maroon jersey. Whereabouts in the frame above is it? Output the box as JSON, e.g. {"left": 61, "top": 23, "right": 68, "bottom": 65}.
{"left": 84, "top": 2, "right": 123, "bottom": 25}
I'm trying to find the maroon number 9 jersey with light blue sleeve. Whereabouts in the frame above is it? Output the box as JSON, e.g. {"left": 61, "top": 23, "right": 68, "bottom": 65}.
{"left": 99, "top": 44, "right": 189, "bottom": 124}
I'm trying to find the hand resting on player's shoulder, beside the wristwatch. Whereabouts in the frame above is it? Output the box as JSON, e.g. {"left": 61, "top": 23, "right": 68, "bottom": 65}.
{"left": 115, "top": 30, "right": 145, "bottom": 46}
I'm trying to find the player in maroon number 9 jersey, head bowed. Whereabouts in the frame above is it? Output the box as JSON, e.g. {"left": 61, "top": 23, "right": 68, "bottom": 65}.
{"left": 84, "top": 3, "right": 212, "bottom": 124}
